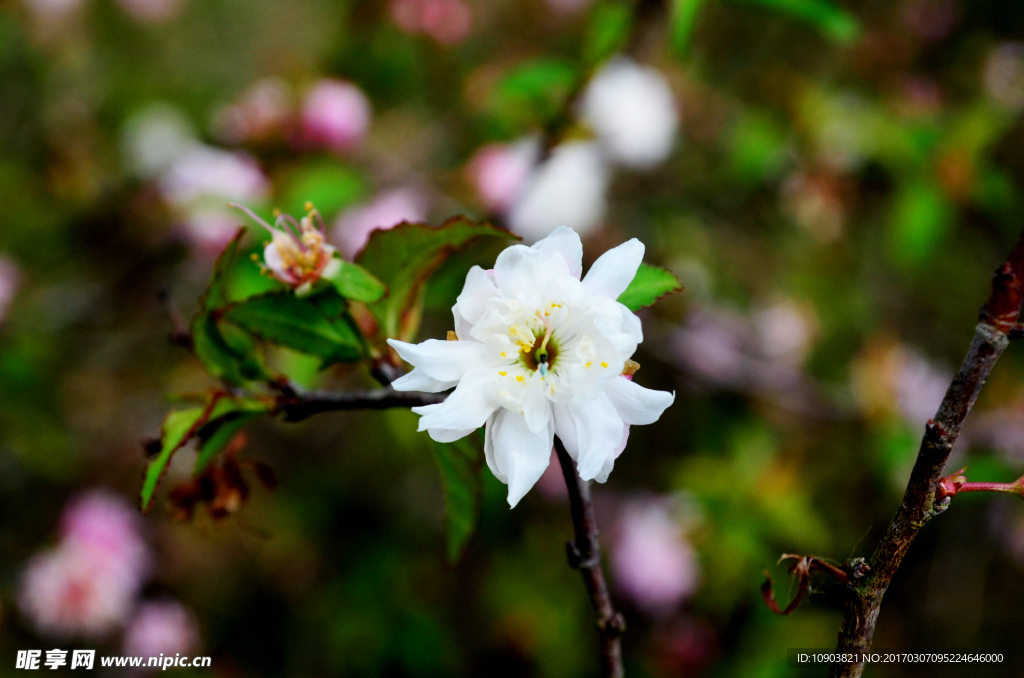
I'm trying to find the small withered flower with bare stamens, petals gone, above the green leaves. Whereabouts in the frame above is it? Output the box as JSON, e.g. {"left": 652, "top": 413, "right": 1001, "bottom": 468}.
{"left": 230, "top": 203, "right": 341, "bottom": 295}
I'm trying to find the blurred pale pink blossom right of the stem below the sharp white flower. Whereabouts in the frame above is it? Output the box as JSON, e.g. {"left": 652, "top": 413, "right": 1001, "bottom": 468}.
{"left": 611, "top": 499, "right": 699, "bottom": 617}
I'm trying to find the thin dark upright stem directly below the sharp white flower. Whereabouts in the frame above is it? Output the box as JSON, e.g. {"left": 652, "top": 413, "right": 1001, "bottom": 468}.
{"left": 555, "top": 438, "right": 626, "bottom": 678}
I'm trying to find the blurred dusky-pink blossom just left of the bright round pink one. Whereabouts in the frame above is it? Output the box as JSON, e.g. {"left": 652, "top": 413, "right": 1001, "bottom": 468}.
{"left": 213, "top": 78, "right": 295, "bottom": 143}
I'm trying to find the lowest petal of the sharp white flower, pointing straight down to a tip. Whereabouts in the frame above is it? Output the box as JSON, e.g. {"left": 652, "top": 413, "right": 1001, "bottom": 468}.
{"left": 492, "top": 410, "right": 555, "bottom": 507}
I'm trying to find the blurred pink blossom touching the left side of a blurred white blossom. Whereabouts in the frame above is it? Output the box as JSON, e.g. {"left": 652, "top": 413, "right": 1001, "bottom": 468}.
{"left": 466, "top": 139, "right": 540, "bottom": 213}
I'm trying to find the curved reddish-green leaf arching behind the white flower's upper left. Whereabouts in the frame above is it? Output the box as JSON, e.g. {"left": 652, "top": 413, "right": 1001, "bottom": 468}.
{"left": 356, "top": 216, "right": 518, "bottom": 340}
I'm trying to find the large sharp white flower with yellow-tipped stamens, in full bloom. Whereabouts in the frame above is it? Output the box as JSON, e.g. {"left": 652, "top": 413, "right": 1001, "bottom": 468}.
{"left": 388, "top": 226, "right": 675, "bottom": 506}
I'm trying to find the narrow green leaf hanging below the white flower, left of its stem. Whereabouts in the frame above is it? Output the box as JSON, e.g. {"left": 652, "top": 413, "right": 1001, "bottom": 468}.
{"left": 431, "top": 435, "right": 483, "bottom": 562}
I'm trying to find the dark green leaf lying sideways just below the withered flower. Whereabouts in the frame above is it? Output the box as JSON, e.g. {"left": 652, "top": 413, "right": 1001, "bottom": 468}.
{"left": 223, "top": 288, "right": 365, "bottom": 367}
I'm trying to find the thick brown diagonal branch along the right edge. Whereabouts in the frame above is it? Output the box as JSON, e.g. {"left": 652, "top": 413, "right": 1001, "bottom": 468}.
{"left": 829, "top": 231, "right": 1024, "bottom": 678}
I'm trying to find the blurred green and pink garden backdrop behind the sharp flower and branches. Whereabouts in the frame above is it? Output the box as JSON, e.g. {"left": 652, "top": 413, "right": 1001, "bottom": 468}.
{"left": 6, "top": 0, "right": 1024, "bottom": 678}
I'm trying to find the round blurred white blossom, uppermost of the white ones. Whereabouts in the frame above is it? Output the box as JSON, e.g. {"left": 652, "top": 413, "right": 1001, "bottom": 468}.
{"left": 581, "top": 57, "right": 679, "bottom": 169}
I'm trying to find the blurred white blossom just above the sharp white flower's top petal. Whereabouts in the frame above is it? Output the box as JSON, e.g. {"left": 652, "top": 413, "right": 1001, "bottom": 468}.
{"left": 508, "top": 141, "right": 609, "bottom": 241}
